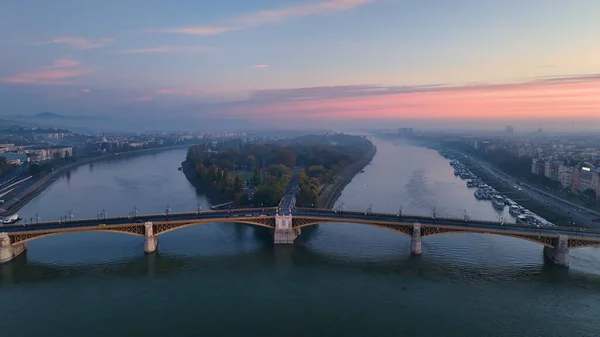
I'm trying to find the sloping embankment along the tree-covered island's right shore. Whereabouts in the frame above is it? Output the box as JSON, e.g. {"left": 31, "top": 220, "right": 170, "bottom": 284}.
{"left": 317, "top": 145, "right": 377, "bottom": 208}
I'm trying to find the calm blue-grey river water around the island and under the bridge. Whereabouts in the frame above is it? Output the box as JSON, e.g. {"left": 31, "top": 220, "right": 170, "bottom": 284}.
{"left": 0, "top": 140, "right": 600, "bottom": 337}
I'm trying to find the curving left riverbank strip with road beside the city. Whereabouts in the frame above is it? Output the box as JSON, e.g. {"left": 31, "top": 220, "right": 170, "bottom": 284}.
{"left": 0, "top": 144, "right": 189, "bottom": 216}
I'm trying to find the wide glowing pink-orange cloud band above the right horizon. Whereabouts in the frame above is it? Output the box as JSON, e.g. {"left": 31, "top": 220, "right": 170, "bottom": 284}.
{"left": 223, "top": 75, "right": 600, "bottom": 120}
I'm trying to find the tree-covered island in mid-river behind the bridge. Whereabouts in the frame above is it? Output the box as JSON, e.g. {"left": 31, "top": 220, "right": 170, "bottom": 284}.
{"left": 182, "top": 134, "right": 376, "bottom": 207}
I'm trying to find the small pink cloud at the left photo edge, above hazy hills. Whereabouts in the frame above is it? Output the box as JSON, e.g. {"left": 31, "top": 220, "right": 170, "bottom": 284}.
{"left": 0, "top": 58, "right": 94, "bottom": 85}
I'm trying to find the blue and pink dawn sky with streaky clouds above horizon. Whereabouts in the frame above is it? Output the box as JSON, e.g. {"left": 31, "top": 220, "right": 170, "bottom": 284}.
{"left": 0, "top": 0, "right": 600, "bottom": 127}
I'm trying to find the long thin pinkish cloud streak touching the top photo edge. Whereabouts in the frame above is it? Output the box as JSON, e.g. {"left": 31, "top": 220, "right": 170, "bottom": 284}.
{"left": 153, "top": 0, "right": 375, "bottom": 35}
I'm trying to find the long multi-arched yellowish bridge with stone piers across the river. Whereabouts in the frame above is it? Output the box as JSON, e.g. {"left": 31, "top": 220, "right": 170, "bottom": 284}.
{"left": 0, "top": 207, "right": 600, "bottom": 267}
